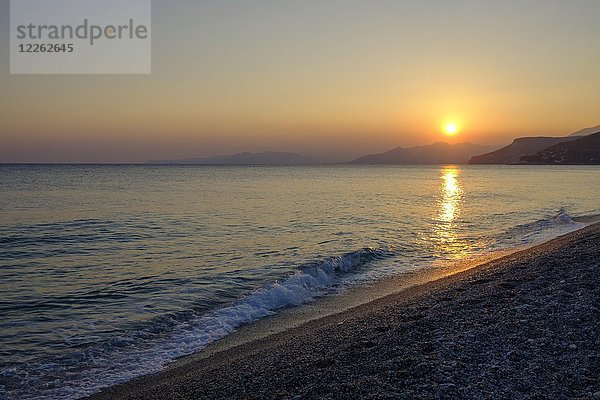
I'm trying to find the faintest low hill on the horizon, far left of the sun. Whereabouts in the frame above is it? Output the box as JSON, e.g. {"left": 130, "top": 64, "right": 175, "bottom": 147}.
{"left": 146, "top": 151, "right": 315, "bottom": 165}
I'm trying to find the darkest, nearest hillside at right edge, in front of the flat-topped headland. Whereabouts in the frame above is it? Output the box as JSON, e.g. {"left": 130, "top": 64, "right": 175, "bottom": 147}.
{"left": 521, "top": 133, "right": 600, "bottom": 165}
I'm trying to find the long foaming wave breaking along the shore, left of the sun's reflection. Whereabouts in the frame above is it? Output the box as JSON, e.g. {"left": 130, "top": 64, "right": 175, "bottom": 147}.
{"left": 0, "top": 248, "right": 394, "bottom": 399}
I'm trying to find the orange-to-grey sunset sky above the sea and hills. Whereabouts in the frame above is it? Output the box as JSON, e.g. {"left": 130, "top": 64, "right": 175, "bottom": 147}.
{"left": 0, "top": 0, "right": 600, "bottom": 163}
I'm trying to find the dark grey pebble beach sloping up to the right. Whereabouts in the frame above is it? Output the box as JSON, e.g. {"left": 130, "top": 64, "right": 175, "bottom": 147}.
{"left": 91, "top": 224, "right": 600, "bottom": 400}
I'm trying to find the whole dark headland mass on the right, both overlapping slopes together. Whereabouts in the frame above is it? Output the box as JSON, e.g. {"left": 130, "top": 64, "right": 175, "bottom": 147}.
{"left": 469, "top": 126, "right": 600, "bottom": 164}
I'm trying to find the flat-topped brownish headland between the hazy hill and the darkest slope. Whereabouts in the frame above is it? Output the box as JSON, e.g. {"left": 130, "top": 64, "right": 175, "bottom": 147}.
{"left": 469, "top": 137, "right": 576, "bottom": 164}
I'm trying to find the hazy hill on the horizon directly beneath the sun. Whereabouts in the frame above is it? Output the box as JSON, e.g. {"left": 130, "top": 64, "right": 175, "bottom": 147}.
{"left": 350, "top": 142, "right": 495, "bottom": 164}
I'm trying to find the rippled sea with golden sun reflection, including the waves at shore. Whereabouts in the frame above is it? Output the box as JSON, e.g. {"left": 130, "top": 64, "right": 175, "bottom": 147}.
{"left": 0, "top": 166, "right": 600, "bottom": 399}
